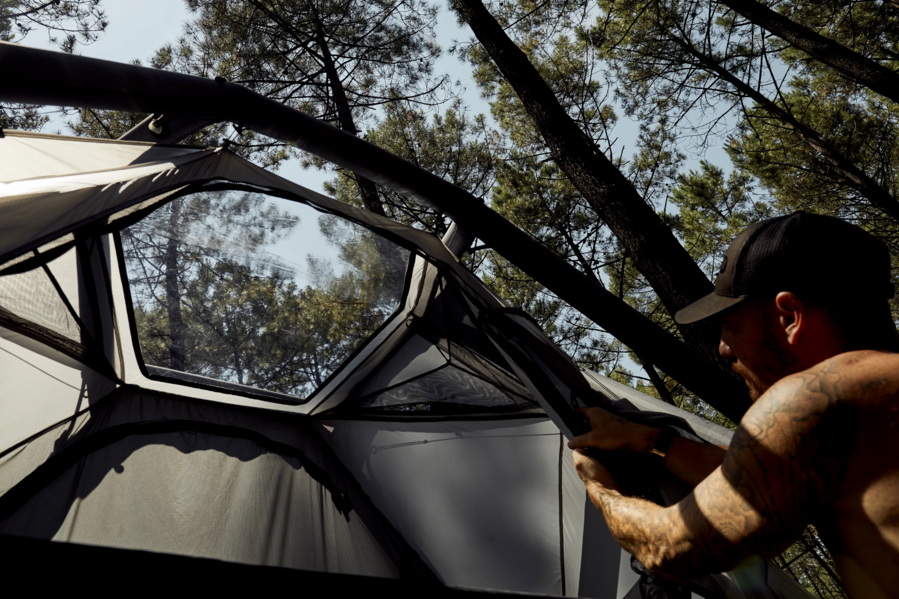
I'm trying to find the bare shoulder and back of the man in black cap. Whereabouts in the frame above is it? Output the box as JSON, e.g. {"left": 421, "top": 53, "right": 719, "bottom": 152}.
{"left": 744, "top": 351, "right": 899, "bottom": 597}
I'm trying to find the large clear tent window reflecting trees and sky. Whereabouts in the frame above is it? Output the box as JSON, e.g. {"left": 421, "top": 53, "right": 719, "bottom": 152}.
{"left": 121, "top": 190, "right": 409, "bottom": 399}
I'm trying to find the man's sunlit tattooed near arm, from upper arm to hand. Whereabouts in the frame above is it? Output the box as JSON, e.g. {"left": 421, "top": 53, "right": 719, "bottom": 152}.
{"left": 575, "top": 363, "right": 840, "bottom": 578}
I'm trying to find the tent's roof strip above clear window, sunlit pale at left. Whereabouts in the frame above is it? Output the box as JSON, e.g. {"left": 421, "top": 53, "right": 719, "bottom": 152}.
{"left": 0, "top": 131, "right": 472, "bottom": 271}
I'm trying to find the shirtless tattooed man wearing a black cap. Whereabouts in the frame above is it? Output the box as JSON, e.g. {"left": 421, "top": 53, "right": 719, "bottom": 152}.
{"left": 569, "top": 212, "right": 899, "bottom": 598}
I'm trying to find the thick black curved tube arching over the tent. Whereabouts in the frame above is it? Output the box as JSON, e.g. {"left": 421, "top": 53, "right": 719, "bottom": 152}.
{"left": 0, "top": 42, "right": 749, "bottom": 422}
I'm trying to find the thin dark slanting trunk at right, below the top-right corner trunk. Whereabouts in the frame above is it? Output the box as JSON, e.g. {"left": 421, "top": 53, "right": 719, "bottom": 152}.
{"left": 671, "top": 36, "right": 899, "bottom": 220}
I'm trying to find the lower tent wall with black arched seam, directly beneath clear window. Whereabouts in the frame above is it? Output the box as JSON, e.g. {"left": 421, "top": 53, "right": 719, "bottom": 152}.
{"left": 0, "top": 387, "right": 436, "bottom": 580}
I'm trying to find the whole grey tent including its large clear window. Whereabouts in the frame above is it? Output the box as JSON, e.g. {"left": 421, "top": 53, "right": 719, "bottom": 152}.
{"left": 0, "top": 44, "right": 803, "bottom": 599}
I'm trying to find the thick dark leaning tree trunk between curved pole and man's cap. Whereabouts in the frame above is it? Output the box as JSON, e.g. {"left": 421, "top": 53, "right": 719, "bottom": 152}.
{"left": 452, "top": 0, "right": 729, "bottom": 371}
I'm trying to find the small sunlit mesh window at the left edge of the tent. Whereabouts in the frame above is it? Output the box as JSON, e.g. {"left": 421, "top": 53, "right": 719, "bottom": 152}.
{"left": 0, "top": 248, "right": 82, "bottom": 343}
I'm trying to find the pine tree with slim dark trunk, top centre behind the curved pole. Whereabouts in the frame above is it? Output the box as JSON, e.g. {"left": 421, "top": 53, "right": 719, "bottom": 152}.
{"left": 166, "top": 0, "right": 447, "bottom": 215}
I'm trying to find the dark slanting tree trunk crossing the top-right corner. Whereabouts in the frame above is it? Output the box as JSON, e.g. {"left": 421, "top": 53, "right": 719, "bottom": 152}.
{"left": 720, "top": 0, "right": 899, "bottom": 103}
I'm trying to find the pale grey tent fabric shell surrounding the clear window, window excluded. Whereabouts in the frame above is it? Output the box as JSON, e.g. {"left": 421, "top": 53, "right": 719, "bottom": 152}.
{"left": 0, "top": 132, "right": 808, "bottom": 599}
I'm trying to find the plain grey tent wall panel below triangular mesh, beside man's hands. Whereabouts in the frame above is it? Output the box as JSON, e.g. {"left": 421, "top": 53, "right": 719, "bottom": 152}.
{"left": 320, "top": 418, "right": 604, "bottom": 594}
